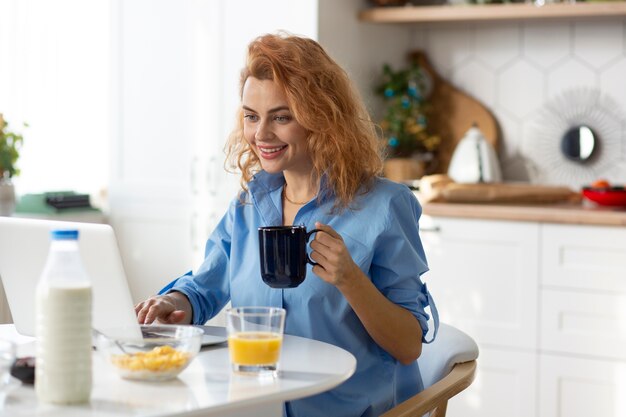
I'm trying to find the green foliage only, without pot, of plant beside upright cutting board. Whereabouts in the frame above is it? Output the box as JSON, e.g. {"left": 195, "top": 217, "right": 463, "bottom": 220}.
{"left": 376, "top": 63, "right": 441, "bottom": 158}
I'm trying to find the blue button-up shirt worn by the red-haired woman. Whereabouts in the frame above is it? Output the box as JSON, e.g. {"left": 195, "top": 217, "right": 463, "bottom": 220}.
{"left": 172, "top": 171, "right": 436, "bottom": 417}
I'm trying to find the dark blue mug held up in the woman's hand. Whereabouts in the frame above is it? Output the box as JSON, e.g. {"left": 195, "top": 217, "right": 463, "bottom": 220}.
{"left": 259, "top": 226, "right": 320, "bottom": 288}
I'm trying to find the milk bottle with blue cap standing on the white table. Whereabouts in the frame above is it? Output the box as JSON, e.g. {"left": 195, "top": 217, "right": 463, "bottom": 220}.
{"left": 35, "top": 230, "right": 92, "bottom": 404}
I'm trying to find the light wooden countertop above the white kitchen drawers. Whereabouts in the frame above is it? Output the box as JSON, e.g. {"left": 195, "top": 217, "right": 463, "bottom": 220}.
{"left": 416, "top": 197, "right": 626, "bottom": 226}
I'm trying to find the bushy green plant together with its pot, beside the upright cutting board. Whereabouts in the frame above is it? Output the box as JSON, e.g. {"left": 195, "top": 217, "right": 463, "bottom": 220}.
{"left": 376, "top": 62, "right": 441, "bottom": 181}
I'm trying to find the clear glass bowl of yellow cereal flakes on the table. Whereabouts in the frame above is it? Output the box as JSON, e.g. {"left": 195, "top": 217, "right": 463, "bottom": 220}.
{"left": 96, "top": 325, "right": 204, "bottom": 381}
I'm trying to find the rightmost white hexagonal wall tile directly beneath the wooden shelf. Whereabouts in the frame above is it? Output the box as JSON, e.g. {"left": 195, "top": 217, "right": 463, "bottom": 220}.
{"left": 574, "top": 20, "right": 624, "bottom": 68}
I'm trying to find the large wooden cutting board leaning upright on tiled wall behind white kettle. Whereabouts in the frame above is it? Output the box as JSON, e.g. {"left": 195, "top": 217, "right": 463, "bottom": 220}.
{"left": 410, "top": 51, "right": 501, "bottom": 173}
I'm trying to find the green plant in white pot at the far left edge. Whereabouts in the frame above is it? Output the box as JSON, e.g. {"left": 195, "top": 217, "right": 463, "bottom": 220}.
{"left": 0, "top": 113, "right": 26, "bottom": 216}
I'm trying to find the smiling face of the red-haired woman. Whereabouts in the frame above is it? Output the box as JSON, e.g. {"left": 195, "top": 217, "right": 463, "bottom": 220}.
{"left": 242, "top": 77, "right": 313, "bottom": 175}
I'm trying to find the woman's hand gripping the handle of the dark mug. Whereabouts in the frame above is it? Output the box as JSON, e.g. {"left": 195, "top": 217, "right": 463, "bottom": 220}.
{"left": 311, "top": 222, "right": 358, "bottom": 286}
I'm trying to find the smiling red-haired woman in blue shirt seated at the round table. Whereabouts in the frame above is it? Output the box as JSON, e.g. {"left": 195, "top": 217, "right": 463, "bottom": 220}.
{"left": 136, "top": 35, "right": 435, "bottom": 417}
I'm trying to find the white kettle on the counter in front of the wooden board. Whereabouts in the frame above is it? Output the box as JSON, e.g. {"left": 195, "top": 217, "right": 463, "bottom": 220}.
{"left": 448, "top": 125, "right": 502, "bottom": 183}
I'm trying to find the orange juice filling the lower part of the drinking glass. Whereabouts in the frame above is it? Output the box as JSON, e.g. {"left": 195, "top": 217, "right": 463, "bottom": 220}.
{"left": 228, "top": 332, "right": 283, "bottom": 365}
